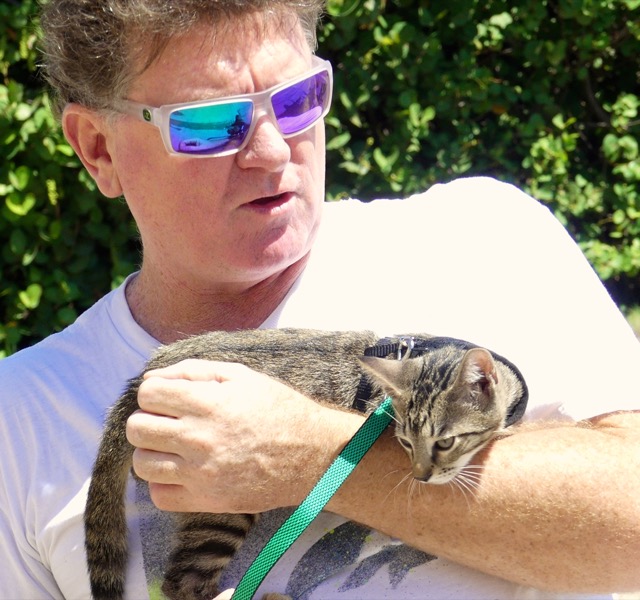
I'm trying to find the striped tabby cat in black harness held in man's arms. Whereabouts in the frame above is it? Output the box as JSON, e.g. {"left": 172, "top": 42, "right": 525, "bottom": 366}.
{"left": 84, "top": 329, "right": 527, "bottom": 600}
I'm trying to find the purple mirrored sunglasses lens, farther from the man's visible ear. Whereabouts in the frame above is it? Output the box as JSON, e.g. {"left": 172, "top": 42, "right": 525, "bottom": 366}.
{"left": 271, "top": 71, "right": 329, "bottom": 135}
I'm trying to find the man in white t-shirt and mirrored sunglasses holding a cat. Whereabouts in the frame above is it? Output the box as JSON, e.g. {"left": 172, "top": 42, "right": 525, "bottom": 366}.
{"left": 0, "top": 0, "right": 640, "bottom": 599}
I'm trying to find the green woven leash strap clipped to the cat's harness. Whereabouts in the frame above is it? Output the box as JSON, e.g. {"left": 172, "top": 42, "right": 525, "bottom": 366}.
{"left": 231, "top": 397, "right": 393, "bottom": 600}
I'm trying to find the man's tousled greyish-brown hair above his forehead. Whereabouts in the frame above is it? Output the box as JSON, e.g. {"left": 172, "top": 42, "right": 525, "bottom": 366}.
{"left": 41, "top": 0, "right": 324, "bottom": 115}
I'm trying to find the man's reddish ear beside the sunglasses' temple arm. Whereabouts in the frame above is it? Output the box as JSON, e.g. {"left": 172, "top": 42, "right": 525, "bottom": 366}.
{"left": 62, "top": 103, "right": 122, "bottom": 198}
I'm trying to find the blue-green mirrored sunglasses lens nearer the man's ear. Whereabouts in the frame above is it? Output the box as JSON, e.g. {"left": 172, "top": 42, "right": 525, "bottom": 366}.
{"left": 169, "top": 101, "right": 253, "bottom": 155}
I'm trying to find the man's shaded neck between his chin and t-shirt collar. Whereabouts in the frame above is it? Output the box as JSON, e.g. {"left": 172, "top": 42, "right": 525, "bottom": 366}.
{"left": 126, "top": 256, "right": 308, "bottom": 344}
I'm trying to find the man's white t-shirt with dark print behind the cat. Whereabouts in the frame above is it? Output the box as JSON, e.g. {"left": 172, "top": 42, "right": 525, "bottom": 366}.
{"left": 0, "top": 179, "right": 640, "bottom": 600}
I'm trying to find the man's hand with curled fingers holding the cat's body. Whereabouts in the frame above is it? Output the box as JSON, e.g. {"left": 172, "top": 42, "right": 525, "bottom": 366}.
{"left": 127, "top": 360, "right": 362, "bottom": 512}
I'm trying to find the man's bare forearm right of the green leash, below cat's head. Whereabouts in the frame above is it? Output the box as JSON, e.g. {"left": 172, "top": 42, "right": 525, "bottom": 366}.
{"left": 329, "top": 413, "right": 640, "bottom": 592}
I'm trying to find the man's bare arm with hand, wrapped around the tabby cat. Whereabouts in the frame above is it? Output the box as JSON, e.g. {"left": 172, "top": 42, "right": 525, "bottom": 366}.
{"left": 128, "top": 361, "right": 640, "bottom": 592}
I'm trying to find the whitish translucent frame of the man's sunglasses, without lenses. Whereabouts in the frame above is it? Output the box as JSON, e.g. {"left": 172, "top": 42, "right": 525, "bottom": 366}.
{"left": 117, "top": 55, "right": 333, "bottom": 158}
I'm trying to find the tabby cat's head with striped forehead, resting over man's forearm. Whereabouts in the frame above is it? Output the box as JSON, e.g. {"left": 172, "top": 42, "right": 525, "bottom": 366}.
{"left": 361, "top": 348, "right": 505, "bottom": 484}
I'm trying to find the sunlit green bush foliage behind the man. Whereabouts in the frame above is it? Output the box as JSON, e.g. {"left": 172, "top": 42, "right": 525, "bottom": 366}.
{"left": 0, "top": 0, "right": 640, "bottom": 353}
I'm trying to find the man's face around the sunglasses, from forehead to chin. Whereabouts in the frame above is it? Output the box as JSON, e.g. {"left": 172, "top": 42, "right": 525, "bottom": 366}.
{"left": 109, "top": 15, "right": 325, "bottom": 292}
